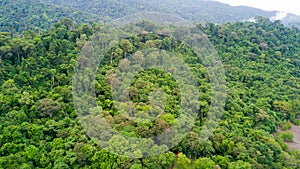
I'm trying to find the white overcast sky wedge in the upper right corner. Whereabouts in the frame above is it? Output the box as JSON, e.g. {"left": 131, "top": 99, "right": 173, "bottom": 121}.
{"left": 215, "top": 0, "right": 300, "bottom": 15}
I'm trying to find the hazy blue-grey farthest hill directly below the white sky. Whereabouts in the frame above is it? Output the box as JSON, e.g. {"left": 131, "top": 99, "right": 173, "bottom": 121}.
{"left": 44, "top": 0, "right": 276, "bottom": 23}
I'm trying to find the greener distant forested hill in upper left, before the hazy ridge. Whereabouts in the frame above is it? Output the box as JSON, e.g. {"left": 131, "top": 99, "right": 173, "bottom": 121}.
{"left": 0, "top": 0, "right": 103, "bottom": 32}
